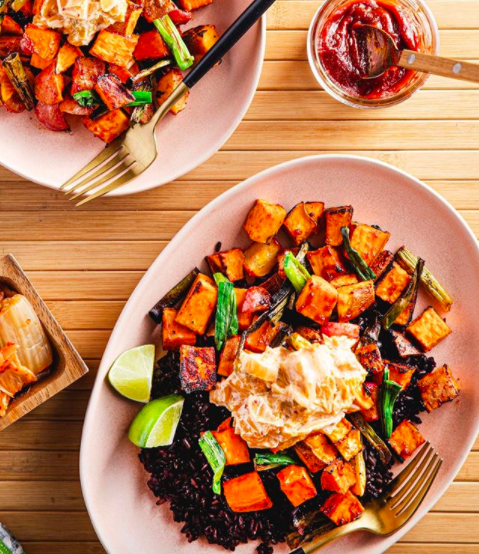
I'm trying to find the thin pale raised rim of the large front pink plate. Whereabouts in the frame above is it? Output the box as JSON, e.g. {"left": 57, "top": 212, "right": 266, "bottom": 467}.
{"left": 79, "top": 154, "right": 479, "bottom": 554}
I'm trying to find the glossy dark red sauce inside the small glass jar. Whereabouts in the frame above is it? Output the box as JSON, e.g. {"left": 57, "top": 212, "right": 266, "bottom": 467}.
{"left": 318, "top": 0, "right": 421, "bottom": 99}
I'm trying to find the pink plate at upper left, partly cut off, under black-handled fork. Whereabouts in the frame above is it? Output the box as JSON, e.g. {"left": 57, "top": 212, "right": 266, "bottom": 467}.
{"left": 0, "top": 8, "right": 266, "bottom": 196}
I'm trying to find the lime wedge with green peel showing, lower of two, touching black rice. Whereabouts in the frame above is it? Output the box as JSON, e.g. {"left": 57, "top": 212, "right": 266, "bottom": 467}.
{"left": 128, "top": 394, "right": 185, "bottom": 448}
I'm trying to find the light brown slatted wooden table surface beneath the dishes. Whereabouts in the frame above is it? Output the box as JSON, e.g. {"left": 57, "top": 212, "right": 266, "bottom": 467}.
{"left": 0, "top": 0, "right": 479, "bottom": 554}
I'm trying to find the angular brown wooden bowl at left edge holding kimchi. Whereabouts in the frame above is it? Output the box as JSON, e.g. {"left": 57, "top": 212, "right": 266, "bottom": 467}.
{"left": 0, "top": 254, "right": 88, "bottom": 431}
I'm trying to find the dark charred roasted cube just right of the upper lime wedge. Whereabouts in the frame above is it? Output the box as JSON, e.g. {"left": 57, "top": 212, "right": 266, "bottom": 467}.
{"left": 180, "top": 345, "right": 216, "bottom": 394}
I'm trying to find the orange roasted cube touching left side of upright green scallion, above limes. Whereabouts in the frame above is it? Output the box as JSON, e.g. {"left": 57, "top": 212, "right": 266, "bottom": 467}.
{"left": 176, "top": 273, "right": 218, "bottom": 335}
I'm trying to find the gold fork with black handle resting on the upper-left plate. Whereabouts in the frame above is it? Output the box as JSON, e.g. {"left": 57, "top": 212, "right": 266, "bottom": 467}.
{"left": 60, "top": 0, "right": 275, "bottom": 206}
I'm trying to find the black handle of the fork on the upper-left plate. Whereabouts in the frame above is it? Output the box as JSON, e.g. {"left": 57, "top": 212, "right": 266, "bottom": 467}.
{"left": 183, "top": 0, "right": 276, "bottom": 88}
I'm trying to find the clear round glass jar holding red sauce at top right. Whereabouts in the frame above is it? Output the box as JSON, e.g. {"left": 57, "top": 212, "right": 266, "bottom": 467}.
{"left": 307, "top": 0, "right": 439, "bottom": 108}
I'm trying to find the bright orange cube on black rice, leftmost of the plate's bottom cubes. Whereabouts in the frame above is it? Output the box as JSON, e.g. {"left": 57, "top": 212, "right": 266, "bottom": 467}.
{"left": 223, "top": 471, "right": 273, "bottom": 512}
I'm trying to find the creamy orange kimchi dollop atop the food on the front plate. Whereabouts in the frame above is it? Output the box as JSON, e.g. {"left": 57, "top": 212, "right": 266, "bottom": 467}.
{"left": 210, "top": 337, "right": 367, "bottom": 450}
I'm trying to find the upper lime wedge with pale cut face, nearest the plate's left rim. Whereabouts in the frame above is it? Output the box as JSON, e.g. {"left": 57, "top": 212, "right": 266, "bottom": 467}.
{"left": 108, "top": 344, "right": 155, "bottom": 402}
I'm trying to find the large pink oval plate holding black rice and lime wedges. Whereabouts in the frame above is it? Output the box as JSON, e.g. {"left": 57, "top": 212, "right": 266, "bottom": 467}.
{"left": 80, "top": 156, "right": 479, "bottom": 554}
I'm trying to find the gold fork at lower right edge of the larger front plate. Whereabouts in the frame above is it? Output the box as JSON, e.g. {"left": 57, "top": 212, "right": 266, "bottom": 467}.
{"left": 290, "top": 442, "right": 442, "bottom": 554}
